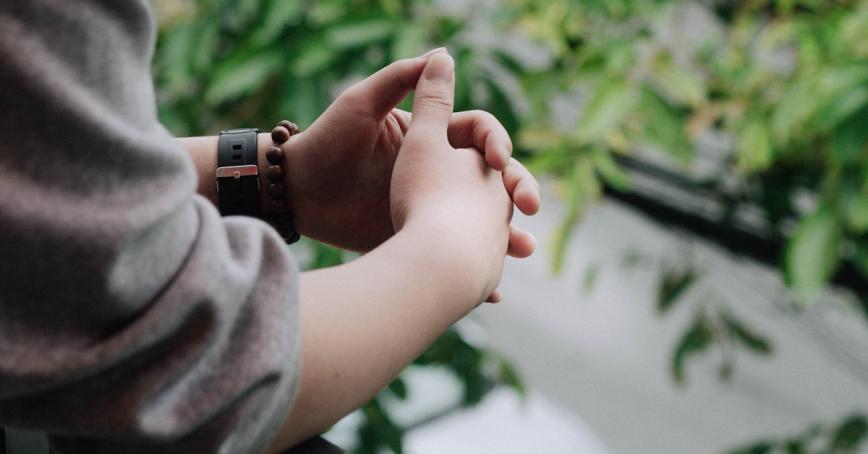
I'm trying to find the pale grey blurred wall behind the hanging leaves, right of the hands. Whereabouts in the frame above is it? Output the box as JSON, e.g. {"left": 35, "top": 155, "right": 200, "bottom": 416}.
{"left": 473, "top": 191, "right": 868, "bottom": 453}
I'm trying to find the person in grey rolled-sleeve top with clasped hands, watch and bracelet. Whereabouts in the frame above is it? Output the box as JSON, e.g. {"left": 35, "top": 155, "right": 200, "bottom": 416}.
{"left": 0, "top": 0, "right": 540, "bottom": 453}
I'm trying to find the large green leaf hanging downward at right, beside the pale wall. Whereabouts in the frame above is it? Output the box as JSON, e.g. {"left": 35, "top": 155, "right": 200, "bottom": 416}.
{"left": 784, "top": 208, "right": 842, "bottom": 303}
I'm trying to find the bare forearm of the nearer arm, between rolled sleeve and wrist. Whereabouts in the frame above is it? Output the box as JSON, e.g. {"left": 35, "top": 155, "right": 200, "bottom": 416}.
{"left": 272, "top": 218, "right": 485, "bottom": 452}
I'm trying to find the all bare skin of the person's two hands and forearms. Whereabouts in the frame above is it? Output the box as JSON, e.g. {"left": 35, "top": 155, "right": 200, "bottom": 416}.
{"left": 182, "top": 50, "right": 539, "bottom": 452}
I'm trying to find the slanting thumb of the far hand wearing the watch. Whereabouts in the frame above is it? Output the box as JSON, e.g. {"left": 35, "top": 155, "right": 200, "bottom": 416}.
{"left": 342, "top": 47, "right": 446, "bottom": 119}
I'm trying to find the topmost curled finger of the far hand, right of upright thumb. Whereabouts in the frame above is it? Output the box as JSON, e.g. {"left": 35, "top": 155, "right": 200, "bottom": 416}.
{"left": 449, "top": 110, "right": 512, "bottom": 170}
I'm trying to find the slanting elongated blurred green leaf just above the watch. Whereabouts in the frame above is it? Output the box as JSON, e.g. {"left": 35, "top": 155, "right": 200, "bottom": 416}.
{"left": 205, "top": 49, "right": 283, "bottom": 106}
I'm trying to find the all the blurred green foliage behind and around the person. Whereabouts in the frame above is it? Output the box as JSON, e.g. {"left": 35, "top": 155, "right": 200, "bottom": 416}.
{"left": 154, "top": 0, "right": 868, "bottom": 452}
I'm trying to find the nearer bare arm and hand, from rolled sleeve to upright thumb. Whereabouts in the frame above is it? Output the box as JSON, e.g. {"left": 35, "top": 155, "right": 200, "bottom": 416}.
{"left": 271, "top": 52, "right": 511, "bottom": 452}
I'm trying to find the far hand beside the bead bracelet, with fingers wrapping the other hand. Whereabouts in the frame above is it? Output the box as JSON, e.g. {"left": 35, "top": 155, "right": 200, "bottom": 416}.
{"left": 286, "top": 50, "right": 540, "bottom": 257}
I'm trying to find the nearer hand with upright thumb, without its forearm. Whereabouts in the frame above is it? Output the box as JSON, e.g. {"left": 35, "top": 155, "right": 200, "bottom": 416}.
{"left": 391, "top": 54, "right": 520, "bottom": 302}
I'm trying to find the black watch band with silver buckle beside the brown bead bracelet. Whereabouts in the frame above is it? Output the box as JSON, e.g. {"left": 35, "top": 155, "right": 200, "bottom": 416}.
{"left": 217, "top": 128, "right": 261, "bottom": 217}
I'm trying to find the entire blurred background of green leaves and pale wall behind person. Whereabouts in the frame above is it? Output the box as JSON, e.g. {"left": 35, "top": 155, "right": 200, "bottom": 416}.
{"left": 152, "top": 0, "right": 868, "bottom": 454}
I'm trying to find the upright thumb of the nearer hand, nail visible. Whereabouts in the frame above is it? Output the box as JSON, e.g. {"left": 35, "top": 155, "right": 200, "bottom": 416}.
{"left": 410, "top": 53, "right": 455, "bottom": 137}
